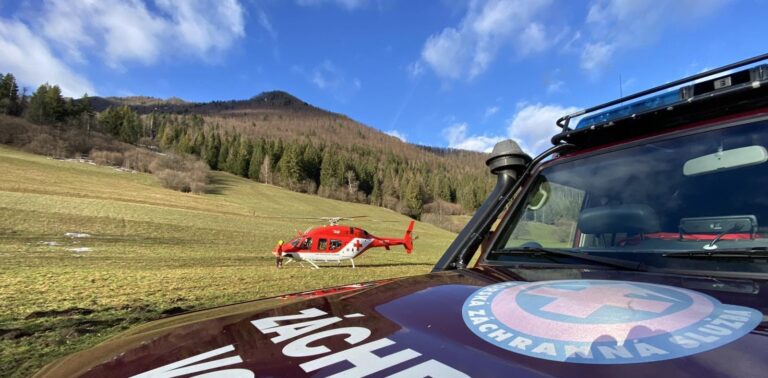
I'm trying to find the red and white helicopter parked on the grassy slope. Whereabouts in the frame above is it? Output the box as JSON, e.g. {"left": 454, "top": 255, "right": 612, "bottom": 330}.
{"left": 272, "top": 217, "right": 414, "bottom": 269}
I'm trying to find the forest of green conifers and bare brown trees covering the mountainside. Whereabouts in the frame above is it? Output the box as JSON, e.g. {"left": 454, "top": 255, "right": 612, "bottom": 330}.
{"left": 0, "top": 74, "right": 493, "bottom": 219}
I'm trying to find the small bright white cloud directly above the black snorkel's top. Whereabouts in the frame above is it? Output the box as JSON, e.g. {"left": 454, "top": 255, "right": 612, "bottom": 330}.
{"left": 507, "top": 103, "right": 579, "bottom": 155}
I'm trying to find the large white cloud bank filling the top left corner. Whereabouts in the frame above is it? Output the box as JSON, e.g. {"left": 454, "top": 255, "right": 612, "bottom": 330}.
{"left": 0, "top": 0, "right": 246, "bottom": 96}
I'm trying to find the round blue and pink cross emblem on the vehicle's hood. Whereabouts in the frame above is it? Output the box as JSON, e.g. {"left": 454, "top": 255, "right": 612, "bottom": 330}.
{"left": 462, "top": 280, "right": 763, "bottom": 364}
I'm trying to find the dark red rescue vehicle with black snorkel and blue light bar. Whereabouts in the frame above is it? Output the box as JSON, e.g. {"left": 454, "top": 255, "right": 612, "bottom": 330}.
{"left": 34, "top": 55, "right": 768, "bottom": 378}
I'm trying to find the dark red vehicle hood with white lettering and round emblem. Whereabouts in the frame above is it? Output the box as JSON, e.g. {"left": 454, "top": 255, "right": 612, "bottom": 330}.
{"left": 38, "top": 267, "right": 768, "bottom": 377}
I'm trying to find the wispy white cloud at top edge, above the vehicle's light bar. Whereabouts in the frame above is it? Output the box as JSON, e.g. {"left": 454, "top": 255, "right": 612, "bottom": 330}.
{"left": 581, "top": 0, "right": 730, "bottom": 72}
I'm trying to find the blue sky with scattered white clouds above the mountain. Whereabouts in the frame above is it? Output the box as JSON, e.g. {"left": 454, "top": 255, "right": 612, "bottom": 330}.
{"left": 0, "top": 0, "right": 768, "bottom": 152}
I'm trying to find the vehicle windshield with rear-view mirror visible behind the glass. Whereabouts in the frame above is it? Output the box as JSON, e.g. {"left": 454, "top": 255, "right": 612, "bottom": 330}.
{"left": 486, "top": 116, "right": 768, "bottom": 272}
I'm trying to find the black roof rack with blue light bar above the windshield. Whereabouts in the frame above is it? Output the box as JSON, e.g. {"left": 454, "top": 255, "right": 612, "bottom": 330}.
{"left": 552, "top": 54, "right": 768, "bottom": 150}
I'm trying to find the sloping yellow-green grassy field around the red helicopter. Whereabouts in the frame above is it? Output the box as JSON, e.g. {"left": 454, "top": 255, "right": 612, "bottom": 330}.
{"left": 0, "top": 146, "right": 454, "bottom": 376}
